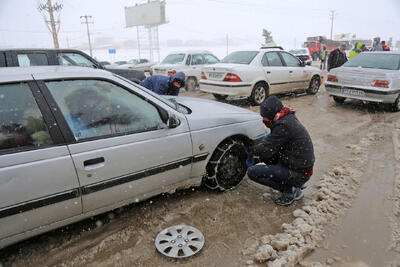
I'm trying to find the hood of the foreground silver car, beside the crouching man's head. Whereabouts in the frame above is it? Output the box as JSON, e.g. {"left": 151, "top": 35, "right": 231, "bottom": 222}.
{"left": 175, "top": 96, "right": 261, "bottom": 131}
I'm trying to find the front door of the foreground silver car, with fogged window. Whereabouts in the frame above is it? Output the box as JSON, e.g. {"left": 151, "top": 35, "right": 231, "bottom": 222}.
{"left": 42, "top": 79, "right": 192, "bottom": 212}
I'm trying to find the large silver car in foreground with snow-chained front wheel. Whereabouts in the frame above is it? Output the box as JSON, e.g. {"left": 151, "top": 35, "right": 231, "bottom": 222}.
{"left": 0, "top": 66, "right": 265, "bottom": 248}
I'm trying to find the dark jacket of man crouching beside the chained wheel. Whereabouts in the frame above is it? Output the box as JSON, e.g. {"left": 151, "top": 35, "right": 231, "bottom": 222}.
{"left": 250, "top": 96, "right": 315, "bottom": 173}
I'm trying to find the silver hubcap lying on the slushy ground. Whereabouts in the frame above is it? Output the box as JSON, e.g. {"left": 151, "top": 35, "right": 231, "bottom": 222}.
{"left": 155, "top": 225, "right": 204, "bottom": 258}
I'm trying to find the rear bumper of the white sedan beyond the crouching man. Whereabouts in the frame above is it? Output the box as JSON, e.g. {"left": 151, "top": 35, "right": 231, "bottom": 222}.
{"left": 200, "top": 80, "right": 253, "bottom": 96}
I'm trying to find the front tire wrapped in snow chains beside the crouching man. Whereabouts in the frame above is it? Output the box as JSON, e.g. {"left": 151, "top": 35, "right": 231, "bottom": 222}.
{"left": 205, "top": 139, "right": 247, "bottom": 191}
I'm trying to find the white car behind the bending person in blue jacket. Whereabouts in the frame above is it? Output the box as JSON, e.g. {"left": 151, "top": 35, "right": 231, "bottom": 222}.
{"left": 151, "top": 50, "right": 219, "bottom": 90}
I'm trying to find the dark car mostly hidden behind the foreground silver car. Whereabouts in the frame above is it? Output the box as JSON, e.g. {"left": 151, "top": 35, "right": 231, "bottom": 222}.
{"left": 0, "top": 48, "right": 146, "bottom": 83}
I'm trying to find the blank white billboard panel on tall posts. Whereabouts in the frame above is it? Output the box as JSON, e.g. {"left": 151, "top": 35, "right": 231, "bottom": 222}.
{"left": 125, "top": 1, "right": 165, "bottom": 27}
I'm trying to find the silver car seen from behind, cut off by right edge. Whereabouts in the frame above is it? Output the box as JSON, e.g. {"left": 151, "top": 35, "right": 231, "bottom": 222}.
{"left": 325, "top": 52, "right": 400, "bottom": 111}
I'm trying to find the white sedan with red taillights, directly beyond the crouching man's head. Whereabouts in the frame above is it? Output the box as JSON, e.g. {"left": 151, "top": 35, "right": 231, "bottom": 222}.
{"left": 200, "top": 48, "right": 322, "bottom": 105}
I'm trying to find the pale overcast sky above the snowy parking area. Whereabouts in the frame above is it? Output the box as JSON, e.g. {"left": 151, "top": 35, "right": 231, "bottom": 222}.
{"left": 0, "top": 0, "right": 400, "bottom": 47}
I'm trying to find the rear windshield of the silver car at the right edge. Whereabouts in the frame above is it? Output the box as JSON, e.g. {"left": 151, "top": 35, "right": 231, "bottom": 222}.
{"left": 343, "top": 52, "right": 400, "bottom": 70}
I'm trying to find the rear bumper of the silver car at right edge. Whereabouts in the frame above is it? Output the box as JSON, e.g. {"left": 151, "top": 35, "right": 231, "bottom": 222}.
{"left": 325, "top": 84, "right": 400, "bottom": 103}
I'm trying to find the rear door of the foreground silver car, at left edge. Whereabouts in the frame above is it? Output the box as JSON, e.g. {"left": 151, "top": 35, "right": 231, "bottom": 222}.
{"left": 0, "top": 80, "right": 82, "bottom": 242}
